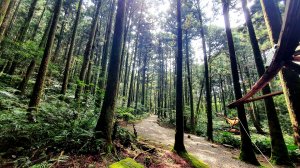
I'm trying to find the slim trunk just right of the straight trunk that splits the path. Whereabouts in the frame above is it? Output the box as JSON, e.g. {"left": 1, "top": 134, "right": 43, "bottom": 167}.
{"left": 185, "top": 30, "right": 195, "bottom": 133}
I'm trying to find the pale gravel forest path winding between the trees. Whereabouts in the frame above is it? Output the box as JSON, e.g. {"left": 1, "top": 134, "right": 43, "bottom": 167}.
{"left": 129, "top": 115, "right": 255, "bottom": 168}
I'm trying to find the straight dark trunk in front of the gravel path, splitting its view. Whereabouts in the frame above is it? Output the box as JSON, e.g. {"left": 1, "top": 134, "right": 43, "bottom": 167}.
{"left": 174, "top": 0, "right": 186, "bottom": 153}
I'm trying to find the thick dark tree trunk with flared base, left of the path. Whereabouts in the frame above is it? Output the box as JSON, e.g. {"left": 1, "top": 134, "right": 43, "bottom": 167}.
{"left": 95, "top": 0, "right": 126, "bottom": 146}
